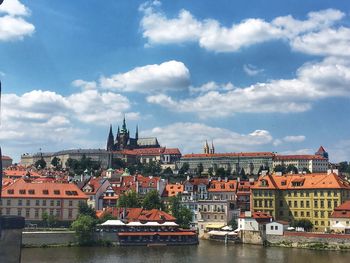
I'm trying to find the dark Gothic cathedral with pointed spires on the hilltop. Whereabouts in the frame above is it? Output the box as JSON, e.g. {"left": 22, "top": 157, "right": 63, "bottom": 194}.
{"left": 107, "top": 117, "right": 160, "bottom": 151}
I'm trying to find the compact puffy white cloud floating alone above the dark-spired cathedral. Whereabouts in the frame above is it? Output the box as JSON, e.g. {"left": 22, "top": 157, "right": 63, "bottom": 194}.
{"left": 100, "top": 60, "right": 190, "bottom": 93}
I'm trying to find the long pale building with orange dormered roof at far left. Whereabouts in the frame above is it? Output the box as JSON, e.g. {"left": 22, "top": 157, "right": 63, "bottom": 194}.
{"left": 1, "top": 179, "right": 87, "bottom": 222}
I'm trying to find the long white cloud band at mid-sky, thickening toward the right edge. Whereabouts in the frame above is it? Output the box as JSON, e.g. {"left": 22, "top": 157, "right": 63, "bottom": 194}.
{"left": 147, "top": 58, "right": 350, "bottom": 118}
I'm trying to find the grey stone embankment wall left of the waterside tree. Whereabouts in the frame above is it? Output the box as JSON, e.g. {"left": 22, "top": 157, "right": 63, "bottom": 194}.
{"left": 22, "top": 231, "right": 76, "bottom": 247}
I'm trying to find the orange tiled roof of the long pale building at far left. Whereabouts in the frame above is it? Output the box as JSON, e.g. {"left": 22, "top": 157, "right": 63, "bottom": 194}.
{"left": 2, "top": 179, "right": 87, "bottom": 199}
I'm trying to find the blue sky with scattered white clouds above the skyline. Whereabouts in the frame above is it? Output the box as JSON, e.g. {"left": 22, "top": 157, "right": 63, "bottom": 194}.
{"left": 0, "top": 0, "right": 350, "bottom": 162}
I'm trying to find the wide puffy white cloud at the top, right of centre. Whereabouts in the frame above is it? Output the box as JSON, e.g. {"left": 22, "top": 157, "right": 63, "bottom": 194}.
{"left": 140, "top": 2, "right": 345, "bottom": 52}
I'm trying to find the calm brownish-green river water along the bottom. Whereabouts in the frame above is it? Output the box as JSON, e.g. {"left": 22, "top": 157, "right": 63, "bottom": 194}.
{"left": 22, "top": 241, "right": 350, "bottom": 263}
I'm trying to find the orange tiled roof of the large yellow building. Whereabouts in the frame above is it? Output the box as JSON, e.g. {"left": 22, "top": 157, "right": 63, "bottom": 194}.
{"left": 251, "top": 173, "right": 350, "bottom": 190}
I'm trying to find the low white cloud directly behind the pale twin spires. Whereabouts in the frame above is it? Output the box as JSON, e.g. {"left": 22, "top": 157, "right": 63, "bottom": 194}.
{"left": 141, "top": 122, "right": 273, "bottom": 153}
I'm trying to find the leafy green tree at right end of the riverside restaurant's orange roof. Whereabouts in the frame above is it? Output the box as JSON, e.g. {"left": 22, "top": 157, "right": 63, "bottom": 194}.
{"left": 169, "top": 196, "right": 193, "bottom": 228}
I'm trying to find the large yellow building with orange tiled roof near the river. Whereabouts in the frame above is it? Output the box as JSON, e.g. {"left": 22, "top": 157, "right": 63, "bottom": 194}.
{"left": 251, "top": 173, "right": 350, "bottom": 231}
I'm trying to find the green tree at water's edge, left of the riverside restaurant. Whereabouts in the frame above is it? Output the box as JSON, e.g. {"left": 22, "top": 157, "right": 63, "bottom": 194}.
{"left": 71, "top": 215, "right": 96, "bottom": 245}
